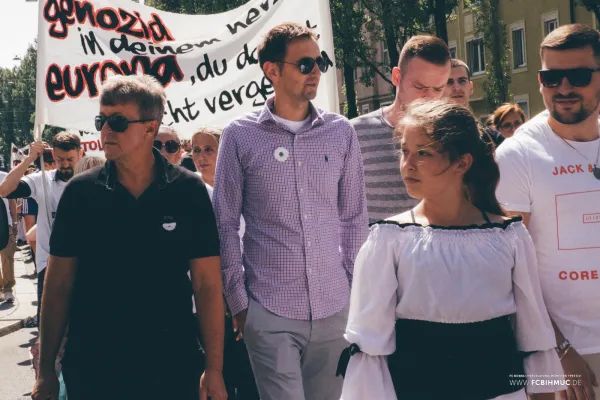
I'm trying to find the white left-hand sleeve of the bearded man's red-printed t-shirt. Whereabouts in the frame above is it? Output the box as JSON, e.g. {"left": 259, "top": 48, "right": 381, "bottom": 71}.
{"left": 496, "top": 138, "right": 531, "bottom": 213}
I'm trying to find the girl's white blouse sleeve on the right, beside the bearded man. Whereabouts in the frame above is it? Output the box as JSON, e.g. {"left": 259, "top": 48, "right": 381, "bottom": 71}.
{"left": 513, "top": 224, "right": 566, "bottom": 393}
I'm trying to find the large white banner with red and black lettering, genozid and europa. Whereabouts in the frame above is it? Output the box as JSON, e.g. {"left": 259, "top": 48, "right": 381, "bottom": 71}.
{"left": 36, "top": 0, "right": 339, "bottom": 145}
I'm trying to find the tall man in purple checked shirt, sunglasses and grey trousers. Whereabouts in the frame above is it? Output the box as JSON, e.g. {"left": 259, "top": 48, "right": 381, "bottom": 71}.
{"left": 213, "top": 23, "right": 368, "bottom": 400}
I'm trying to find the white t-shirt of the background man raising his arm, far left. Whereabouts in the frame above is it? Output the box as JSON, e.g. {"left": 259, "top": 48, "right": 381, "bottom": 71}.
{"left": 21, "top": 170, "right": 67, "bottom": 272}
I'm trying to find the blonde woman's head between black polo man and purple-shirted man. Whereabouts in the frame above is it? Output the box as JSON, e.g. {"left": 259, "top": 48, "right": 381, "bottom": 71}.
{"left": 191, "top": 128, "right": 221, "bottom": 188}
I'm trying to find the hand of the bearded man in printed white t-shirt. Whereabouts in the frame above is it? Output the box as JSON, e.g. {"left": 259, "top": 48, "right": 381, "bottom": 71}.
{"left": 560, "top": 348, "right": 598, "bottom": 400}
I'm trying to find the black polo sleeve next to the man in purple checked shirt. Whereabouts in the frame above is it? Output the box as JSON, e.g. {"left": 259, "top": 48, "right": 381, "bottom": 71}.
{"left": 188, "top": 177, "right": 220, "bottom": 260}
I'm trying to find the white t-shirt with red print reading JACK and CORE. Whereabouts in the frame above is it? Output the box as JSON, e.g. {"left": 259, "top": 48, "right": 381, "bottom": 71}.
{"left": 497, "top": 118, "right": 600, "bottom": 354}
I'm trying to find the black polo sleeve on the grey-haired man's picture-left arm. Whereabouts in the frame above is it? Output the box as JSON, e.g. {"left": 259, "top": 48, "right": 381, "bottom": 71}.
{"left": 50, "top": 181, "right": 87, "bottom": 257}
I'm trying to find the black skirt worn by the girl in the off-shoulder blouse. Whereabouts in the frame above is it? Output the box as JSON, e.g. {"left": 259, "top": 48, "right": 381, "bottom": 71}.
{"left": 388, "top": 316, "right": 525, "bottom": 400}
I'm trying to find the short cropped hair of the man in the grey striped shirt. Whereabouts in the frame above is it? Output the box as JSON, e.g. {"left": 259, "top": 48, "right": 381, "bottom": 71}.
{"left": 398, "top": 35, "right": 451, "bottom": 73}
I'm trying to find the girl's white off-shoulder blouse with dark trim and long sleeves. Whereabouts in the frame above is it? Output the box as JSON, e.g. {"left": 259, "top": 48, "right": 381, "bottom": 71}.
{"left": 342, "top": 218, "right": 566, "bottom": 400}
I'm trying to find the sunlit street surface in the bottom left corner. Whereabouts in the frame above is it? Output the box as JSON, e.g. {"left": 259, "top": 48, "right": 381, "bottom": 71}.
{"left": 0, "top": 328, "right": 37, "bottom": 400}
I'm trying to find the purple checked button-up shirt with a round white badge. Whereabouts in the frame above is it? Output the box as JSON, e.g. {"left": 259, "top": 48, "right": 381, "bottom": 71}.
{"left": 213, "top": 98, "right": 368, "bottom": 320}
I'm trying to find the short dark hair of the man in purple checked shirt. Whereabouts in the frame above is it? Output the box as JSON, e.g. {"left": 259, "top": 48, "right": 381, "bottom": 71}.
{"left": 258, "top": 22, "right": 317, "bottom": 69}
